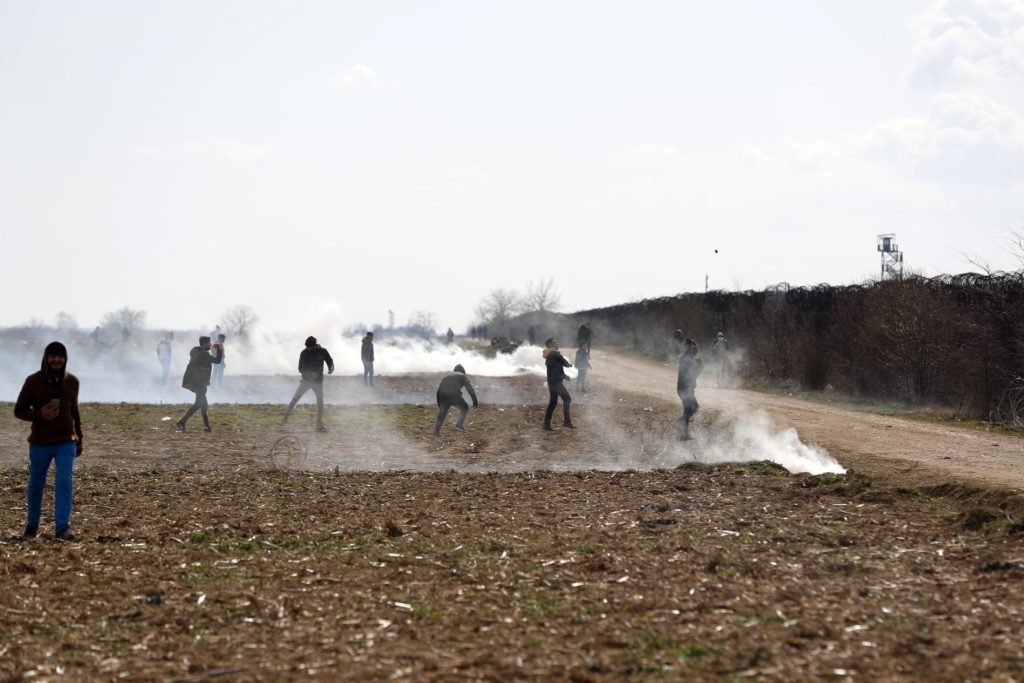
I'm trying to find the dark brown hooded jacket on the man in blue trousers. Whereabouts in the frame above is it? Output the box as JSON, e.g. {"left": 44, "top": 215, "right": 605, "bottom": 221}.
{"left": 14, "top": 342, "right": 82, "bottom": 445}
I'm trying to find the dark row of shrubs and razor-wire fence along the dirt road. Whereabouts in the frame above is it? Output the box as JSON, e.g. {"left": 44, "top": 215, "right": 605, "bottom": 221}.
{"left": 572, "top": 271, "right": 1024, "bottom": 419}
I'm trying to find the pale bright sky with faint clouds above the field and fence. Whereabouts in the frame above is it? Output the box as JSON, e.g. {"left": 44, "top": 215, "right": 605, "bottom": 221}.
{"left": 0, "top": 0, "right": 1024, "bottom": 334}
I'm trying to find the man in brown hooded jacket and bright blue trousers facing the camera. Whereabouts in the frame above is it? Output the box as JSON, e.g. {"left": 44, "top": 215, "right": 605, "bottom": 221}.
{"left": 14, "top": 342, "right": 82, "bottom": 541}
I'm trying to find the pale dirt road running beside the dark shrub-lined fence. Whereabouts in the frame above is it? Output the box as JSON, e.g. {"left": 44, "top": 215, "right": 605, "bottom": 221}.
{"left": 592, "top": 349, "right": 1024, "bottom": 494}
